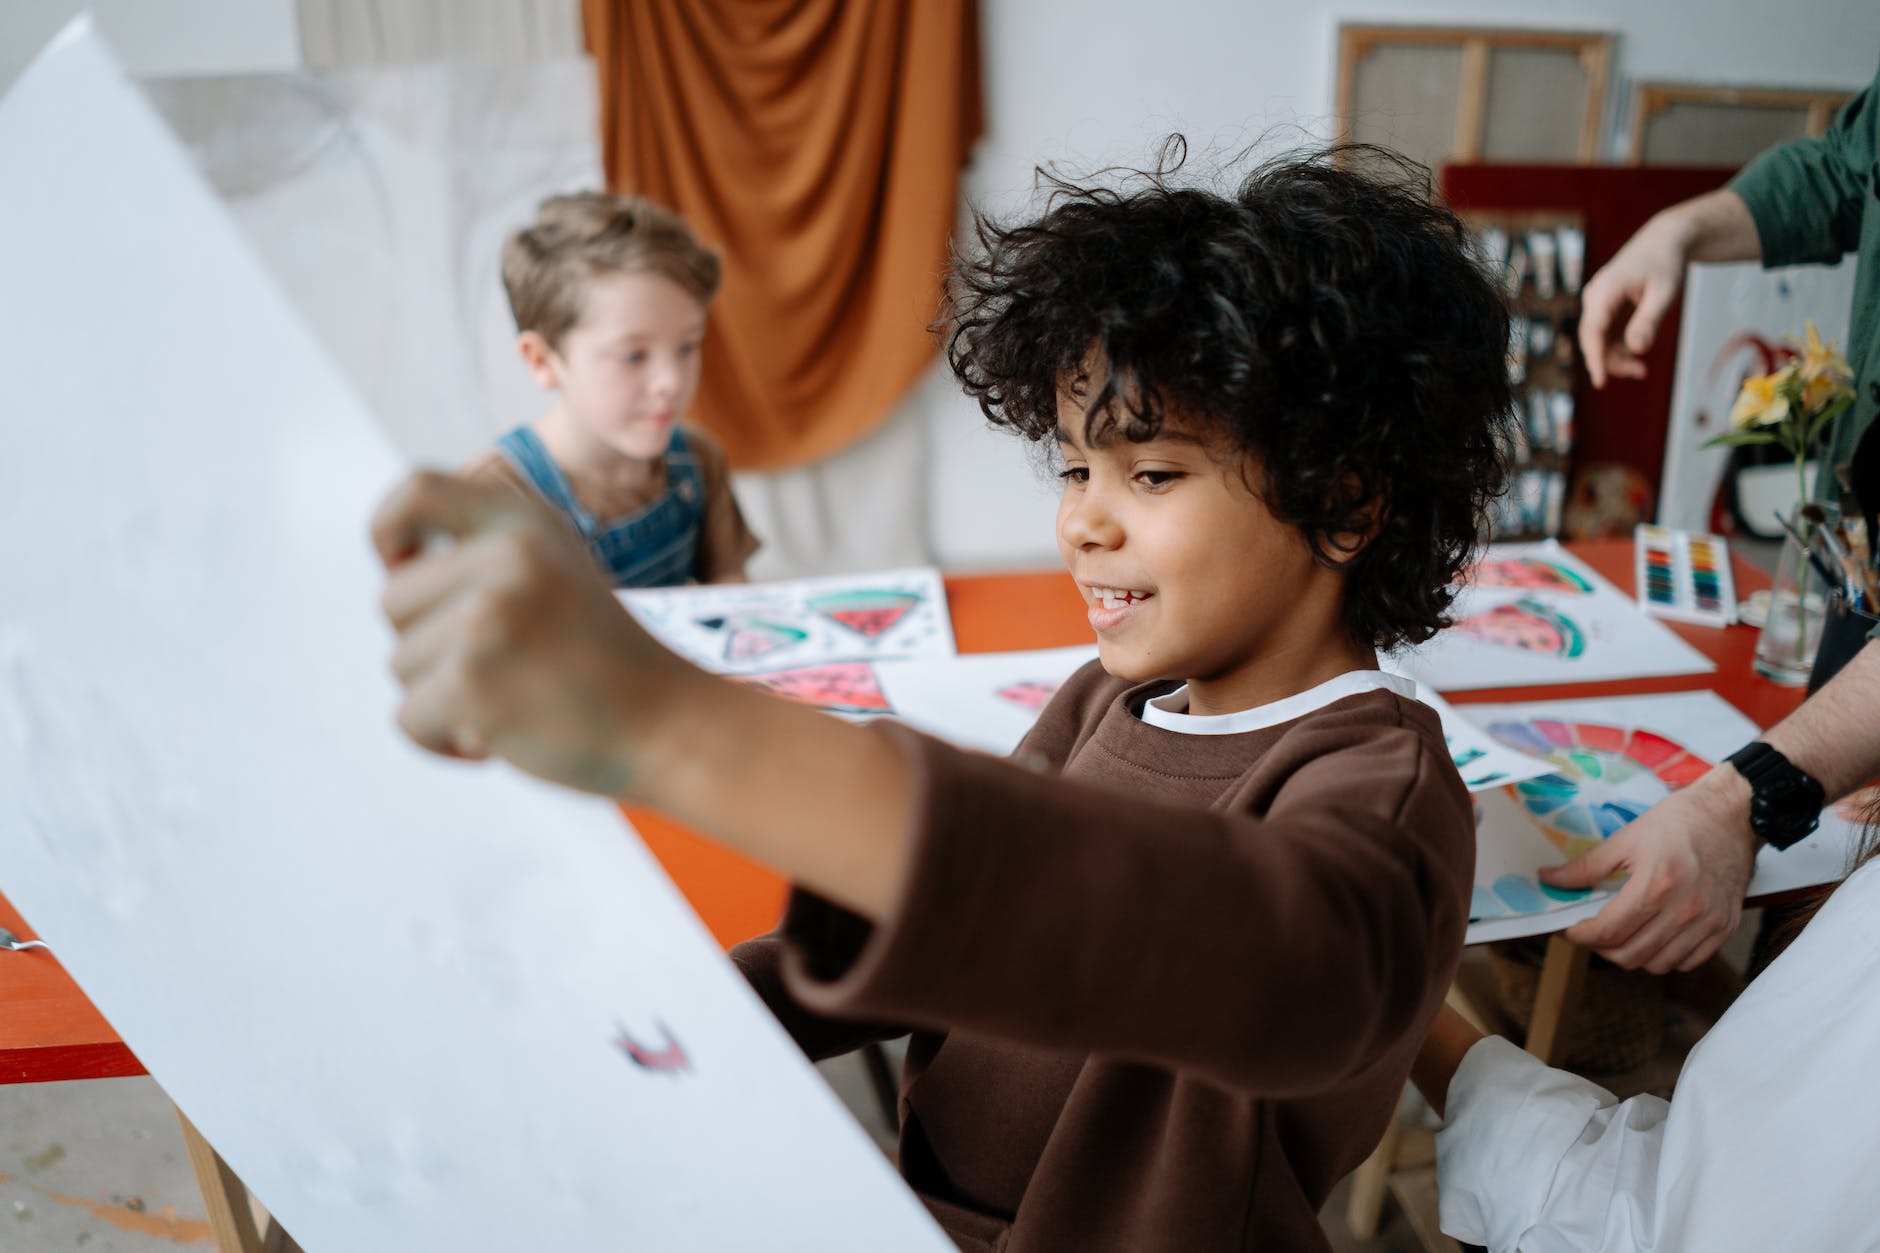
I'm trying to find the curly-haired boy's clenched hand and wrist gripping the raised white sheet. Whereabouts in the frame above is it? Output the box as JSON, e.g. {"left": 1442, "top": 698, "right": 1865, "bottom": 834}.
{"left": 372, "top": 472, "right": 703, "bottom": 798}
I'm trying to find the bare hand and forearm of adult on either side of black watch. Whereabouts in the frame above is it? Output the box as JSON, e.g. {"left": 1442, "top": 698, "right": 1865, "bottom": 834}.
{"left": 1542, "top": 640, "right": 1880, "bottom": 975}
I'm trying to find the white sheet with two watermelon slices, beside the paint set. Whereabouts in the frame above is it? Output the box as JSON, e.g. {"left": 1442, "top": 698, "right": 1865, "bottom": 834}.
{"left": 1389, "top": 540, "right": 1716, "bottom": 692}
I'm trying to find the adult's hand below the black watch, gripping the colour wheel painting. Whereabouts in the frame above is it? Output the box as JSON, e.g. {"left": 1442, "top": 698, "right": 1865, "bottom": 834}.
{"left": 1540, "top": 766, "right": 1756, "bottom": 975}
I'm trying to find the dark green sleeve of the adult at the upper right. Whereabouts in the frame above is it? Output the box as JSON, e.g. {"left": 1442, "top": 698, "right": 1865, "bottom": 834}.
{"left": 1730, "top": 81, "right": 1880, "bottom": 267}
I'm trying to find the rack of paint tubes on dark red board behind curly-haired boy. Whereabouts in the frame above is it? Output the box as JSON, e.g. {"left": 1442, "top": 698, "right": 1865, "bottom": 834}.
{"left": 1463, "top": 211, "right": 1587, "bottom": 540}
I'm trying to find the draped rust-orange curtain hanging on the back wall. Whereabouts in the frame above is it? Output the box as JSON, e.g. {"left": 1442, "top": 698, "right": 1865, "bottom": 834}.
{"left": 583, "top": 0, "right": 981, "bottom": 470}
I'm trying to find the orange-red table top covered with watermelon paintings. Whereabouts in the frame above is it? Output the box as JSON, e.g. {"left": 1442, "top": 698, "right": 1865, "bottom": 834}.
{"left": 0, "top": 540, "right": 1801, "bottom": 1084}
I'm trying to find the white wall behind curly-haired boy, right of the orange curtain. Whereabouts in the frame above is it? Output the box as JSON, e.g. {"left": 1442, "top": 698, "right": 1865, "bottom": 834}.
{"left": 932, "top": 0, "right": 1880, "bottom": 568}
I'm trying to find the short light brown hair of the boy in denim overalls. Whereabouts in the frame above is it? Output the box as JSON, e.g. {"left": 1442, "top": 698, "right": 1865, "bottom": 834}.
{"left": 502, "top": 192, "right": 720, "bottom": 348}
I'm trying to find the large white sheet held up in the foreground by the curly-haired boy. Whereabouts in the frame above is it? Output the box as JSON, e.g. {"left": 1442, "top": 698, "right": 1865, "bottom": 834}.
{"left": 0, "top": 23, "right": 951, "bottom": 1253}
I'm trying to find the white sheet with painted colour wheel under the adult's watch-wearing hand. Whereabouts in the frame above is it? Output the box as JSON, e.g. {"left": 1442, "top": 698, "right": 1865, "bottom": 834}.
{"left": 1461, "top": 692, "right": 1859, "bottom": 944}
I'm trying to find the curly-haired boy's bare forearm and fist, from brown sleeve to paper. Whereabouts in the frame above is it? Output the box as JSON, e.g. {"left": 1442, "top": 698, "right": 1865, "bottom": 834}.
{"left": 372, "top": 472, "right": 910, "bottom": 920}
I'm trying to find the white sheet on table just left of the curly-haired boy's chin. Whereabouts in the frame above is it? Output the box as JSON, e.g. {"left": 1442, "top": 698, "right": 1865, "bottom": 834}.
{"left": 874, "top": 643, "right": 1096, "bottom": 754}
